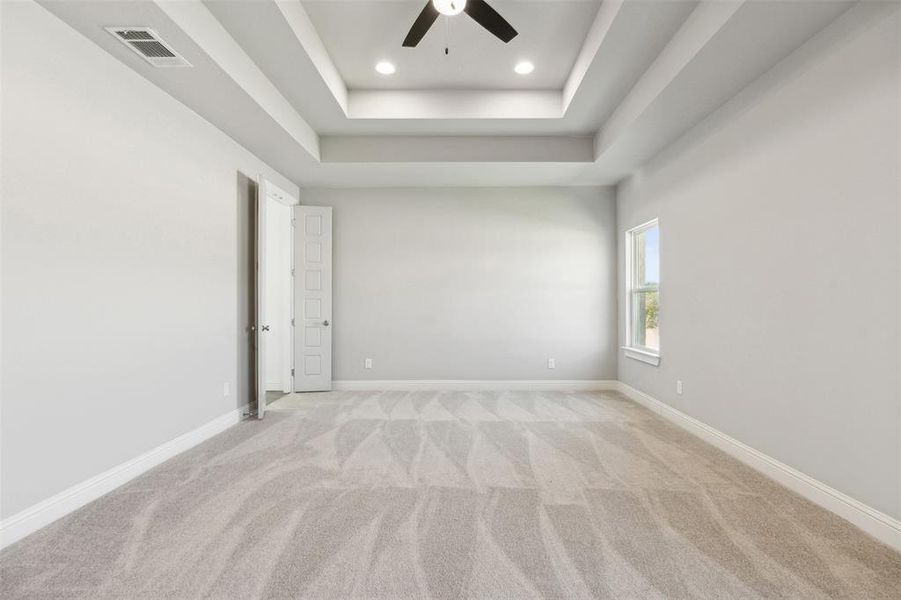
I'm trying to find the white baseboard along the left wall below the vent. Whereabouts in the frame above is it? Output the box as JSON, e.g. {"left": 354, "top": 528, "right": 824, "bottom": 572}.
{"left": 0, "top": 406, "right": 248, "bottom": 548}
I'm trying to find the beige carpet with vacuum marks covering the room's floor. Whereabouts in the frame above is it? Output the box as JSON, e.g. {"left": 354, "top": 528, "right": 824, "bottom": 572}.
{"left": 0, "top": 392, "right": 901, "bottom": 599}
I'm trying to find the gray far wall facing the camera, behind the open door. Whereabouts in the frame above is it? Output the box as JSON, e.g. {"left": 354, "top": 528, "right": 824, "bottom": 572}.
{"left": 301, "top": 188, "right": 616, "bottom": 380}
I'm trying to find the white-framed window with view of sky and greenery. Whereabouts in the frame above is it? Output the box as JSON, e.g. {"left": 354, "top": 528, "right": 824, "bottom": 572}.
{"left": 625, "top": 219, "right": 660, "bottom": 365}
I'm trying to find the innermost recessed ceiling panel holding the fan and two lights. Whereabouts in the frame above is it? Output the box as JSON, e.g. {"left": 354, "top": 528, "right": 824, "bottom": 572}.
{"left": 303, "top": 0, "right": 600, "bottom": 90}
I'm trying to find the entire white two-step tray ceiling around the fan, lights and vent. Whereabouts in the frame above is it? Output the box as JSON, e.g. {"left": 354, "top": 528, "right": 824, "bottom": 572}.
{"left": 39, "top": 0, "right": 880, "bottom": 186}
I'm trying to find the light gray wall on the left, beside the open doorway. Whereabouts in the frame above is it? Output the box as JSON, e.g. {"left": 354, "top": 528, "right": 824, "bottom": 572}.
{"left": 0, "top": 3, "right": 296, "bottom": 517}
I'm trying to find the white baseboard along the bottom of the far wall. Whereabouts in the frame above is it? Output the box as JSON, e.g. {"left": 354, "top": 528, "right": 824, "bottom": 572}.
{"left": 332, "top": 379, "right": 619, "bottom": 392}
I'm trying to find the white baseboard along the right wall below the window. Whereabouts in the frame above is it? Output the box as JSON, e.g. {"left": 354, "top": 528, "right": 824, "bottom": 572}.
{"left": 618, "top": 382, "right": 901, "bottom": 551}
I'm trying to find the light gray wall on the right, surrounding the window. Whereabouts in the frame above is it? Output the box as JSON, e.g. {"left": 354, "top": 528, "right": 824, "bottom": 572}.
{"left": 618, "top": 8, "right": 901, "bottom": 517}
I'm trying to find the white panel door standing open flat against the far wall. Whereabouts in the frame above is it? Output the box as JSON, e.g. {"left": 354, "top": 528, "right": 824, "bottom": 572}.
{"left": 294, "top": 206, "right": 332, "bottom": 392}
